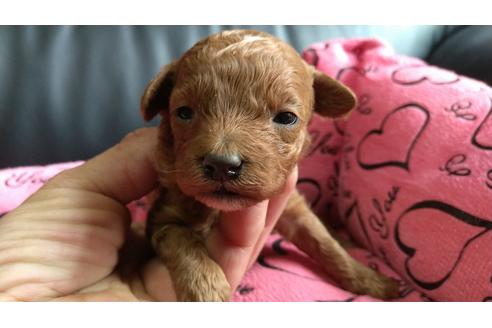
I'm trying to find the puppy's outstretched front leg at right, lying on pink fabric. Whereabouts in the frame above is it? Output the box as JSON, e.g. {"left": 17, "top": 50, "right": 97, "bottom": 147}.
{"left": 276, "top": 192, "right": 398, "bottom": 299}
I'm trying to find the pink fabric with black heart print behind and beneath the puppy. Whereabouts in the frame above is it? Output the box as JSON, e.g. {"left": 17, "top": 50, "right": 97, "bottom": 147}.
{"left": 0, "top": 39, "right": 492, "bottom": 301}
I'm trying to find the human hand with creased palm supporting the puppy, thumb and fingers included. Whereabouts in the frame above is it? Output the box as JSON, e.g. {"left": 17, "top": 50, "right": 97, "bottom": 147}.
{"left": 0, "top": 128, "right": 297, "bottom": 301}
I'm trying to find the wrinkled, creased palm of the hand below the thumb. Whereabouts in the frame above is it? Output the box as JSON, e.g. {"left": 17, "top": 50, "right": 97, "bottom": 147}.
{"left": 0, "top": 187, "right": 167, "bottom": 300}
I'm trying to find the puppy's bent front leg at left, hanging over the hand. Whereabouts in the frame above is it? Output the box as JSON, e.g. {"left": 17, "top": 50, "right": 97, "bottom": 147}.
{"left": 151, "top": 223, "right": 231, "bottom": 302}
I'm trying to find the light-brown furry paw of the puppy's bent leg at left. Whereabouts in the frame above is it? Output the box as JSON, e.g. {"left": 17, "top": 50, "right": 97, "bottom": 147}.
{"left": 175, "top": 258, "right": 231, "bottom": 302}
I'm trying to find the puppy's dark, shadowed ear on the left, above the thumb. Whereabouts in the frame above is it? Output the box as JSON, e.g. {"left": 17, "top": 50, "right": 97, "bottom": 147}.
{"left": 140, "top": 61, "right": 178, "bottom": 121}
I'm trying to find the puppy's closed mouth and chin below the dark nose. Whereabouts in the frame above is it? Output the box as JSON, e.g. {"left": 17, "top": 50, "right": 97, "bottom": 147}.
{"left": 195, "top": 184, "right": 260, "bottom": 211}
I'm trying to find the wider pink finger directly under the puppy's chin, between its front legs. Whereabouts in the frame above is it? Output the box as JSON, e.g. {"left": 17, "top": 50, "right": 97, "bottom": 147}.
{"left": 206, "top": 201, "right": 268, "bottom": 290}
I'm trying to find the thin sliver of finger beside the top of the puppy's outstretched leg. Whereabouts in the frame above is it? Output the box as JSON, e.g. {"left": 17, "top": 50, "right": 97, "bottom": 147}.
{"left": 247, "top": 166, "right": 298, "bottom": 268}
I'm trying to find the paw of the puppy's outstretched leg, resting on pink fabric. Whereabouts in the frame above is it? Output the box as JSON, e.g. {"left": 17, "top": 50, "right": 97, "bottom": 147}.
{"left": 341, "top": 263, "right": 399, "bottom": 299}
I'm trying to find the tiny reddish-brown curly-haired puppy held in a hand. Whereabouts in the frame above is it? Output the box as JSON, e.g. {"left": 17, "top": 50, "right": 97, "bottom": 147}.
{"left": 141, "top": 30, "right": 398, "bottom": 301}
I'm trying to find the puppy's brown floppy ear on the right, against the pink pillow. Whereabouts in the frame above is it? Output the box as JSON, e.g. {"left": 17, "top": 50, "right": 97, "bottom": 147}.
{"left": 313, "top": 70, "right": 357, "bottom": 118}
